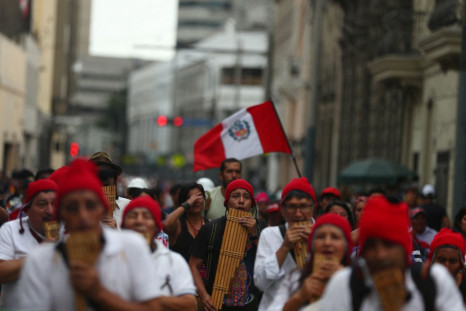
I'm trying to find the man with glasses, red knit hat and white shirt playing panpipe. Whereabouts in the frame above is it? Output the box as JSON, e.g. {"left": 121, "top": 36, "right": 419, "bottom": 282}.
{"left": 254, "top": 177, "right": 316, "bottom": 311}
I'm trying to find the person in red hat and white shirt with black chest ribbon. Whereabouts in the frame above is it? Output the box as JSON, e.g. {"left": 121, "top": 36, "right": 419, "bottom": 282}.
{"left": 121, "top": 196, "right": 196, "bottom": 311}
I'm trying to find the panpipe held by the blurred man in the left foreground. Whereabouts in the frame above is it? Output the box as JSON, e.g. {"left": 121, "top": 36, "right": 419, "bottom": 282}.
{"left": 65, "top": 231, "right": 102, "bottom": 311}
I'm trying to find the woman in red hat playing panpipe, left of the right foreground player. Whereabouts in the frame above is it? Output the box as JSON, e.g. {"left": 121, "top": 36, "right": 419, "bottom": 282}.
{"left": 283, "top": 213, "right": 353, "bottom": 311}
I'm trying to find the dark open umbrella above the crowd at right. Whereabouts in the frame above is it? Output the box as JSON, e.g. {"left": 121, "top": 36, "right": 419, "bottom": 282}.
{"left": 338, "top": 159, "right": 416, "bottom": 185}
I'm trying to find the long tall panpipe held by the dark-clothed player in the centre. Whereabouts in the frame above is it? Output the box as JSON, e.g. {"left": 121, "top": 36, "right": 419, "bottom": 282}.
{"left": 211, "top": 208, "right": 252, "bottom": 310}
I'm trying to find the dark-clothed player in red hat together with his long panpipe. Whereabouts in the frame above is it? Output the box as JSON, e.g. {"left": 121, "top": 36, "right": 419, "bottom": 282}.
{"left": 189, "top": 179, "right": 261, "bottom": 311}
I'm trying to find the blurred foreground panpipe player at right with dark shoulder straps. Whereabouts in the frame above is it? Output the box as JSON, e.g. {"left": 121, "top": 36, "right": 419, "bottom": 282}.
{"left": 322, "top": 196, "right": 465, "bottom": 311}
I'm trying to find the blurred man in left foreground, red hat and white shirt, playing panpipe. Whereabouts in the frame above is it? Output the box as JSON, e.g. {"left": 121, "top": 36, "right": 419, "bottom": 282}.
{"left": 15, "top": 159, "right": 161, "bottom": 311}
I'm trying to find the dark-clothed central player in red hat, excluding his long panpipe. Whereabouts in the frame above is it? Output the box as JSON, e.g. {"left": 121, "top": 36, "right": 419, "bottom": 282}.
{"left": 189, "top": 179, "right": 260, "bottom": 311}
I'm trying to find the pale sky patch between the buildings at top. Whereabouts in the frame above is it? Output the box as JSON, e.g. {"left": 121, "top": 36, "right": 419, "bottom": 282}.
{"left": 89, "top": 0, "right": 178, "bottom": 61}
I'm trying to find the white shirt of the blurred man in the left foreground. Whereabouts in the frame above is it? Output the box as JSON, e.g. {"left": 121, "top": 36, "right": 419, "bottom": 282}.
{"left": 18, "top": 228, "right": 161, "bottom": 310}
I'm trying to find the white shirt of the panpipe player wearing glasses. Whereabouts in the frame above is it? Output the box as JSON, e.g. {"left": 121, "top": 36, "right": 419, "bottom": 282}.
{"left": 254, "top": 226, "right": 297, "bottom": 311}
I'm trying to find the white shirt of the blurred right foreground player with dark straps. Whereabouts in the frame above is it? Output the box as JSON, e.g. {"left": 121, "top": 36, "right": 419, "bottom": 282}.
{"left": 321, "top": 264, "right": 465, "bottom": 311}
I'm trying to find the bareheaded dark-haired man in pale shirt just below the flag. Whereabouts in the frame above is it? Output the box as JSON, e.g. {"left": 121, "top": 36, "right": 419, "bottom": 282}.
{"left": 205, "top": 158, "right": 242, "bottom": 220}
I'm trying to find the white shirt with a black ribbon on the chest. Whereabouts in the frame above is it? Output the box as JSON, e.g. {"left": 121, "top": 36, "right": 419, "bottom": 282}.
{"left": 151, "top": 241, "right": 196, "bottom": 297}
